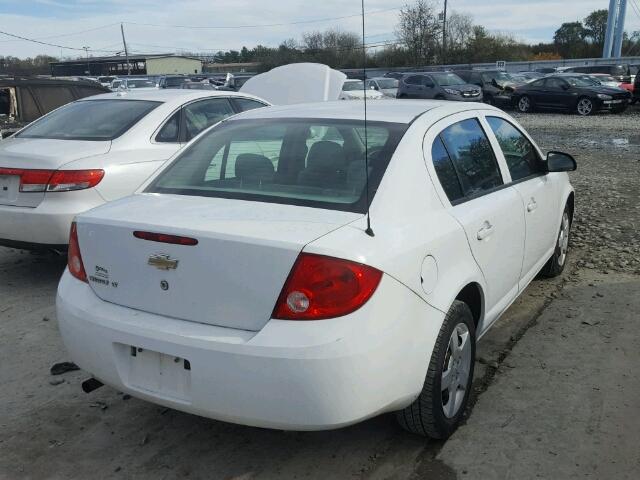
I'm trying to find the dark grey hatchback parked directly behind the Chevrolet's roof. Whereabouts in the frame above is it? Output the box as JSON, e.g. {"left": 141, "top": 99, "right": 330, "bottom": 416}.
{"left": 398, "top": 72, "right": 482, "bottom": 102}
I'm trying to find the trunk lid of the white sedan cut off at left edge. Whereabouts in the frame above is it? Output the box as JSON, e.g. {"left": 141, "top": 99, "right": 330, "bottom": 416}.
{"left": 0, "top": 137, "right": 111, "bottom": 207}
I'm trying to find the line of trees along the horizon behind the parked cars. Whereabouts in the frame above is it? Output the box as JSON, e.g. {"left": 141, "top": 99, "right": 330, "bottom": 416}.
{"left": 0, "top": 0, "right": 640, "bottom": 74}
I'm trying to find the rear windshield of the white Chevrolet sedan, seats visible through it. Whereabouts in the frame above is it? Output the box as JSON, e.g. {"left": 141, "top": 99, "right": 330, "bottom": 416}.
{"left": 147, "top": 119, "right": 407, "bottom": 212}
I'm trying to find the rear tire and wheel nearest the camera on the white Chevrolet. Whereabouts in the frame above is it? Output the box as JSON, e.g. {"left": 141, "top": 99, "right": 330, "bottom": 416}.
{"left": 396, "top": 300, "right": 476, "bottom": 439}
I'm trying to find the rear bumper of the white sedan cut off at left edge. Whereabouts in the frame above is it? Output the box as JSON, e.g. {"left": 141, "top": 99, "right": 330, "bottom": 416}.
{"left": 0, "top": 189, "right": 105, "bottom": 250}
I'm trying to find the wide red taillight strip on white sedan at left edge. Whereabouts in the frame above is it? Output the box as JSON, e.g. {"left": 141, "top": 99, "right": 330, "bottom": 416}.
{"left": 0, "top": 168, "right": 104, "bottom": 192}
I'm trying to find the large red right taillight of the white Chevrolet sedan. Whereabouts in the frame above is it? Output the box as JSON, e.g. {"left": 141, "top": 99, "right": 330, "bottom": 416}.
{"left": 273, "top": 253, "right": 382, "bottom": 320}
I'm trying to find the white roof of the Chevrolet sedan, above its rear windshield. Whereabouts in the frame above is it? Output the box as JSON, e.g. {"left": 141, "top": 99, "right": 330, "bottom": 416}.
{"left": 229, "top": 100, "right": 484, "bottom": 124}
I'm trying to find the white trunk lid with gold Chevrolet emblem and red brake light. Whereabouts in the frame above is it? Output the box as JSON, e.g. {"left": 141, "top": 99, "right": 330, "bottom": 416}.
{"left": 78, "top": 194, "right": 361, "bottom": 331}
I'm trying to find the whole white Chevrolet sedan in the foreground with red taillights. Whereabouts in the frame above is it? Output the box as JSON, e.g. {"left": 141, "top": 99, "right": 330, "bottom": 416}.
{"left": 57, "top": 101, "right": 576, "bottom": 438}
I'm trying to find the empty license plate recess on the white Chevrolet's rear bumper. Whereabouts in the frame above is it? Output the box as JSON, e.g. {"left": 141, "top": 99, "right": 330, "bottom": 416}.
{"left": 116, "top": 344, "right": 191, "bottom": 403}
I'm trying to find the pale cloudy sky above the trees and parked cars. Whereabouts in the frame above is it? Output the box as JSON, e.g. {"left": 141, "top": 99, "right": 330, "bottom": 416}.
{"left": 0, "top": 0, "right": 640, "bottom": 58}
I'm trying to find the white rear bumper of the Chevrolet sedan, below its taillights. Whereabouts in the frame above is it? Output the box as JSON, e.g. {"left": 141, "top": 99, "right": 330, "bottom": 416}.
{"left": 57, "top": 272, "right": 444, "bottom": 430}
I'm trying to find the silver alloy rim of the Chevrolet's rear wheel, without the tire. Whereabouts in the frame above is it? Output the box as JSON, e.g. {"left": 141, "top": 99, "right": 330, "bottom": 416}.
{"left": 440, "top": 323, "right": 471, "bottom": 418}
